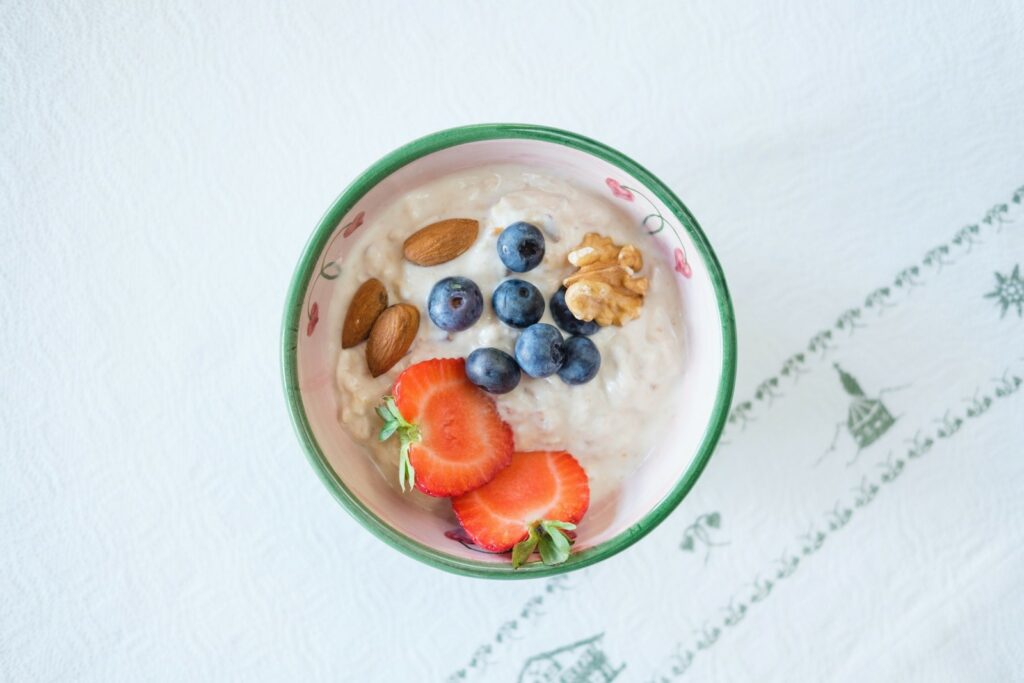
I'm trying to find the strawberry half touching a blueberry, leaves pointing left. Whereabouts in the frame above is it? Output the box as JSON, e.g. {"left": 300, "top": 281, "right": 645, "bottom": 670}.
{"left": 377, "top": 358, "right": 514, "bottom": 497}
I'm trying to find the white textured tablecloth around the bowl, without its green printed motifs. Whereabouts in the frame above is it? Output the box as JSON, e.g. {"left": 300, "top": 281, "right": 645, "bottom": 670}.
{"left": 0, "top": 1, "right": 1024, "bottom": 681}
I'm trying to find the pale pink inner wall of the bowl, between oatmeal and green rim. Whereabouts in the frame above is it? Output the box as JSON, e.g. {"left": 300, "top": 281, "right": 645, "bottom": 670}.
{"left": 297, "top": 139, "right": 724, "bottom": 564}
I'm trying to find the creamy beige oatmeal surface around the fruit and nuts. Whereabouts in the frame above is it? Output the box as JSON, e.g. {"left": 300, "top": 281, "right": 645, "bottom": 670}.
{"left": 331, "top": 165, "right": 685, "bottom": 508}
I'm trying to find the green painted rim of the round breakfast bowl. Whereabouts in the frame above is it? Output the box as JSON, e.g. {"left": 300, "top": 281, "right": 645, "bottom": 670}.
{"left": 281, "top": 123, "right": 736, "bottom": 579}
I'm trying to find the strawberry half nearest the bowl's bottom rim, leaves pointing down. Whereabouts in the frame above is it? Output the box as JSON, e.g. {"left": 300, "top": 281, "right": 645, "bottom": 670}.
{"left": 452, "top": 451, "right": 590, "bottom": 567}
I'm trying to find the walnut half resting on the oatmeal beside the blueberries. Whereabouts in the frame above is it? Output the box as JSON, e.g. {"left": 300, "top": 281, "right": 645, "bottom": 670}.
{"left": 562, "top": 232, "right": 649, "bottom": 326}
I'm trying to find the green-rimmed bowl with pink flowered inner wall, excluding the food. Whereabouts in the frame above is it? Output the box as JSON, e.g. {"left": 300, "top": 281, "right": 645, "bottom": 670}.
{"left": 282, "top": 124, "right": 736, "bottom": 579}
